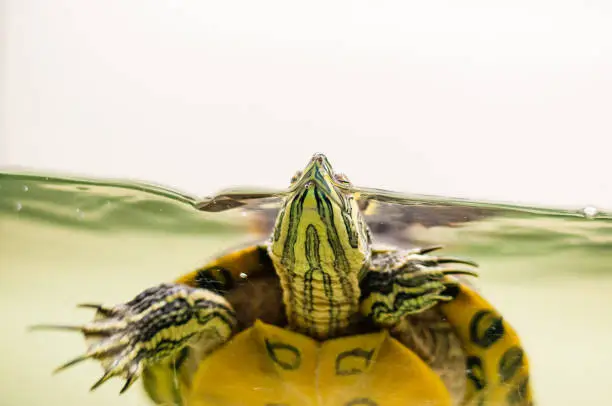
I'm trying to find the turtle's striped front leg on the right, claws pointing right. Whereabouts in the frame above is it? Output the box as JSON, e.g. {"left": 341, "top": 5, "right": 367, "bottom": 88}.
{"left": 360, "top": 247, "right": 477, "bottom": 328}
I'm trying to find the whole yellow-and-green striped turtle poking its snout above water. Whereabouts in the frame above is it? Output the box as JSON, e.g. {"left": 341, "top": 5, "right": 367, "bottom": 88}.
{"left": 38, "top": 154, "right": 533, "bottom": 406}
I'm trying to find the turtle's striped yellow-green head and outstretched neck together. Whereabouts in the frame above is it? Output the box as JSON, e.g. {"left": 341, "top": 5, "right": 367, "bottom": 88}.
{"left": 268, "top": 156, "right": 371, "bottom": 339}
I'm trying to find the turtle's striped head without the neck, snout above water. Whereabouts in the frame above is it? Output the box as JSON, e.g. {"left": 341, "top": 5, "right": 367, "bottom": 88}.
{"left": 269, "top": 154, "right": 370, "bottom": 280}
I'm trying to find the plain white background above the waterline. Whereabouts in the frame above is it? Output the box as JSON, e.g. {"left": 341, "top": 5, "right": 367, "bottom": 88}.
{"left": 0, "top": 0, "right": 612, "bottom": 207}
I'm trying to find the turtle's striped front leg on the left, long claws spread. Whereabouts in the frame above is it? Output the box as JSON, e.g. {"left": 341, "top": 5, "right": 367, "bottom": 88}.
{"left": 37, "top": 284, "right": 237, "bottom": 393}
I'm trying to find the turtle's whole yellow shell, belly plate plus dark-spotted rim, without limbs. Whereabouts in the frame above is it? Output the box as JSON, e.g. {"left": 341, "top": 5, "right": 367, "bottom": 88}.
{"left": 152, "top": 246, "right": 532, "bottom": 406}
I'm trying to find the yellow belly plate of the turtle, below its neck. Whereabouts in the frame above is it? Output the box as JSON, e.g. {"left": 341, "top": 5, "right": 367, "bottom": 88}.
{"left": 187, "top": 321, "right": 451, "bottom": 406}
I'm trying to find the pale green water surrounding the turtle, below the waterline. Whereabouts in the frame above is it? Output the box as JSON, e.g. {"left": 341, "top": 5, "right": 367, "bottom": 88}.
{"left": 0, "top": 173, "right": 612, "bottom": 406}
